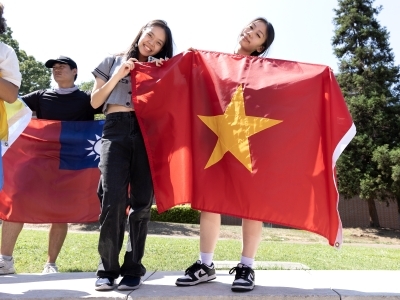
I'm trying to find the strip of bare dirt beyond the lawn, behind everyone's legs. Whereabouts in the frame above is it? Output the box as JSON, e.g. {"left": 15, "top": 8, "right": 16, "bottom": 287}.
{"left": 17, "top": 222, "right": 400, "bottom": 248}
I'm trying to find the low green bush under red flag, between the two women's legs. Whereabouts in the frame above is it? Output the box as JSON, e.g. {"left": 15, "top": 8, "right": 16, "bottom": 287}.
{"left": 150, "top": 205, "right": 200, "bottom": 224}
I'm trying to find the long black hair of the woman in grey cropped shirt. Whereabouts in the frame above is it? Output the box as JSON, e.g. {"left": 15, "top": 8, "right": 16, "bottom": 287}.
{"left": 123, "top": 20, "right": 174, "bottom": 59}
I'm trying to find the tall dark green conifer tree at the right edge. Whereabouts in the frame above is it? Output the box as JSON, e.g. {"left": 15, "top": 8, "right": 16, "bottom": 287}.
{"left": 332, "top": 0, "right": 400, "bottom": 227}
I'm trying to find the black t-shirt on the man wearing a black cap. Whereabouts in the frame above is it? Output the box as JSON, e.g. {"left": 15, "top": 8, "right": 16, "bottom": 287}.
{"left": 21, "top": 90, "right": 103, "bottom": 121}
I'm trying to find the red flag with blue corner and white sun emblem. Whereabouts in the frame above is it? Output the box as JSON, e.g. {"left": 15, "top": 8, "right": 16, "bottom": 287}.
{"left": 0, "top": 119, "right": 104, "bottom": 223}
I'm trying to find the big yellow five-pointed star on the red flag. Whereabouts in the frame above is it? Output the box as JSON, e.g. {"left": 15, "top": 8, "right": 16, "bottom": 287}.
{"left": 198, "top": 85, "right": 282, "bottom": 172}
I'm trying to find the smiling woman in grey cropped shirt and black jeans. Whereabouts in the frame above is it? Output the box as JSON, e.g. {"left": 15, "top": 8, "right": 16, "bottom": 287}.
{"left": 91, "top": 20, "right": 173, "bottom": 290}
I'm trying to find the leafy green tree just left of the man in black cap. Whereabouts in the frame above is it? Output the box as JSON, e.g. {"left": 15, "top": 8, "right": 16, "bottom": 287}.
{"left": 0, "top": 27, "right": 51, "bottom": 95}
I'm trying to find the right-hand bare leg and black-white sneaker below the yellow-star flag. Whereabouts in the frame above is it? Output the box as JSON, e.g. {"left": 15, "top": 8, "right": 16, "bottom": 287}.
{"left": 229, "top": 219, "right": 262, "bottom": 292}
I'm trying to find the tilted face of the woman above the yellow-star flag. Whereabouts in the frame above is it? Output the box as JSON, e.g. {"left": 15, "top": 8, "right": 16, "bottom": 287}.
{"left": 236, "top": 21, "right": 267, "bottom": 55}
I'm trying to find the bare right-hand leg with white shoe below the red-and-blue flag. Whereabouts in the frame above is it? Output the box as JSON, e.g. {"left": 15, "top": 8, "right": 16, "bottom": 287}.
{"left": 42, "top": 223, "right": 68, "bottom": 274}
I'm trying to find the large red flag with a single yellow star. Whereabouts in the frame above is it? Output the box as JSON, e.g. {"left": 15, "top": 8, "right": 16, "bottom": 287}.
{"left": 132, "top": 51, "right": 355, "bottom": 247}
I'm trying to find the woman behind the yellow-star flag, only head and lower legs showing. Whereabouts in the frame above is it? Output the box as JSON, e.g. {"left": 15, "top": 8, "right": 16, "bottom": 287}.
{"left": 175, "top": 18, "right": 275, "bottom": 292}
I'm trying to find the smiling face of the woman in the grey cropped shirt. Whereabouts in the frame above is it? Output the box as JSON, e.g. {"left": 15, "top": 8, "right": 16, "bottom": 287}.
{"left": 138, "top": 26, "right": 166, "bottom": 61}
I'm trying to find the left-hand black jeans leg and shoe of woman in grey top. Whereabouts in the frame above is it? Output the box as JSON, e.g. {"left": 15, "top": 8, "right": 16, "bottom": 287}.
{"left": 95, "top": 112, "right": 131, "bottom": 291}
